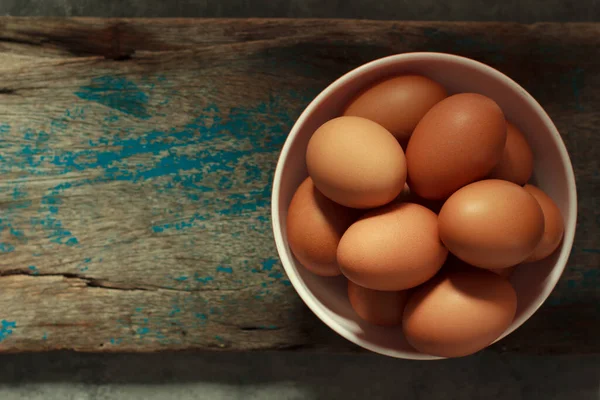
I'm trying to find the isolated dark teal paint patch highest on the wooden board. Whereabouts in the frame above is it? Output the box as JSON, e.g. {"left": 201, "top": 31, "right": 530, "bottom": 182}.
{"left": 75, "top": 76, "right": 151, "bottom": 119}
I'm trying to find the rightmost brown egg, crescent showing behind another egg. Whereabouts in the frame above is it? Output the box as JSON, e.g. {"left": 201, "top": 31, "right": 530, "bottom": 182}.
{"left": 525, "top": 185, "right": 565, "bottom": 262}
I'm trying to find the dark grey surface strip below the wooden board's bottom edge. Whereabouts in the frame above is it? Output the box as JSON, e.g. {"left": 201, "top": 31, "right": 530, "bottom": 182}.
{"left": 0, "top": 352, "right": 600, "bottom": 400}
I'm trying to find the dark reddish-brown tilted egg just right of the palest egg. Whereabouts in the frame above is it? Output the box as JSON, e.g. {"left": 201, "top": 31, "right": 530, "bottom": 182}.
{"left": 406, "top": 93, "right": 506, "bottom": 199}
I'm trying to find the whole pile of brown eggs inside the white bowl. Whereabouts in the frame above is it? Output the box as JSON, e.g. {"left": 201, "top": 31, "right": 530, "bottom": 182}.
{"left": 287, "top": 75, "right": 564, "bottom": 357}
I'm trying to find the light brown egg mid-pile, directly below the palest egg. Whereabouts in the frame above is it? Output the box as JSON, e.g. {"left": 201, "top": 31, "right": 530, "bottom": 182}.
{"left": 337, "top": 203, "right": 448, "bottom": 290}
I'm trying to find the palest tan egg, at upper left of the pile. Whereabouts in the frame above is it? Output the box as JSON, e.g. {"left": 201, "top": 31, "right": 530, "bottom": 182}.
{"left": 306, "top": 117, "right": 406, "bottom": 208}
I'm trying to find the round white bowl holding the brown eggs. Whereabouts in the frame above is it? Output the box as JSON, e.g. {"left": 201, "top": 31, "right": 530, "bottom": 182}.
{"left": 271, "top": 53, "right": 577, "bottom": 360}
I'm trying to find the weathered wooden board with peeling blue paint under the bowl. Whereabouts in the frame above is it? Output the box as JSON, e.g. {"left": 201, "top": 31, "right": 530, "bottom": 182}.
{"left": 0, "top": 18, "right": 600, "bottom": 353}
